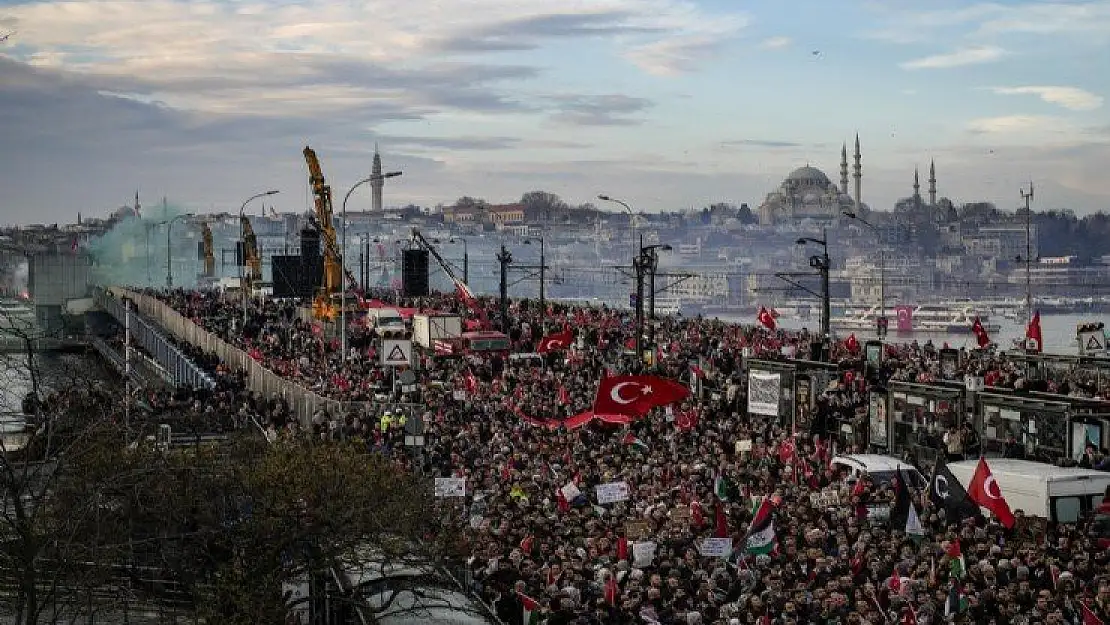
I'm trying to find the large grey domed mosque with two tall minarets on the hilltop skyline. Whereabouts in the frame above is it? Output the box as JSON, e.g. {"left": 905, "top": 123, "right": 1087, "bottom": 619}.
{"left": 759, "top": 134, "right": 866, "bottom": 225}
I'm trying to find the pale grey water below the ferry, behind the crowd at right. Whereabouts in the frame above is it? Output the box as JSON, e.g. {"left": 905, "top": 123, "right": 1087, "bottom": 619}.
{"left": 720, "top": 313, "right": 1096, "bottom": 355}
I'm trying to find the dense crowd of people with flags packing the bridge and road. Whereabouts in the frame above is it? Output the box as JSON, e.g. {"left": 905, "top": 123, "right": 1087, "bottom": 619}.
{"left": 138, "top": 290, "right": 1110, "bottom": 625}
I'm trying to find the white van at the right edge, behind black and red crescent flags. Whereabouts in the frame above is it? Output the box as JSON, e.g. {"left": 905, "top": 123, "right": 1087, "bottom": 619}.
{"left": 948, "top": 457, "right": 1110, "bottom": 523}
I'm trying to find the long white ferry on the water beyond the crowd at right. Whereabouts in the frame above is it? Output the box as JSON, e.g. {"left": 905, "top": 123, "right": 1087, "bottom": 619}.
{"left": 831, "top": 303, "right": 1001, "bottom": 334}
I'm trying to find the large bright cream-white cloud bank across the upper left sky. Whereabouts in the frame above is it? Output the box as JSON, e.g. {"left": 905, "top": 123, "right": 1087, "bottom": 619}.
{"left": 4, "top": 0, "right": 746, "bottom": 114}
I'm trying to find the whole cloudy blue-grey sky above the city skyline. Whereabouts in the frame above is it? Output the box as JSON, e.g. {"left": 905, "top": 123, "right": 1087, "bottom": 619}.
{"left": 0, "top": 0, "right": 1110, "bottom": 223}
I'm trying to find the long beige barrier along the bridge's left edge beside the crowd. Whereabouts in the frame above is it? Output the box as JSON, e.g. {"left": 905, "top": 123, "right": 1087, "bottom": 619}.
{"left": 108, "top": 286, "right": 377, "bottom": 426}
